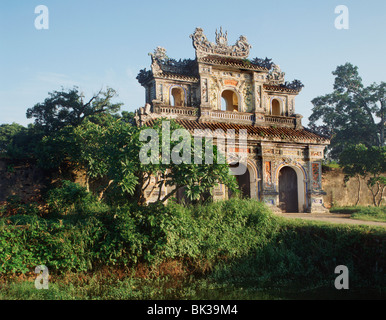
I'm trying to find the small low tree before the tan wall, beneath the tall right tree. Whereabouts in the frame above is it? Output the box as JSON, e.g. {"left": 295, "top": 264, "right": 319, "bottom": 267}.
{"left": 339, "top": 144, "right": 386, "bottom": 206}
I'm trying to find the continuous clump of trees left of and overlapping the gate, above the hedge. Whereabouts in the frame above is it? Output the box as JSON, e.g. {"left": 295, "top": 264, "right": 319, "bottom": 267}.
{"left": 0, "top": 87, "right": 237, "bottom": 204}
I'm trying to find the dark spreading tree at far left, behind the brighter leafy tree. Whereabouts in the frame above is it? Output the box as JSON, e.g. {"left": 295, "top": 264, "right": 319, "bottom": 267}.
{"left": 0, "top": 87, "right": 123, "bottom": 160}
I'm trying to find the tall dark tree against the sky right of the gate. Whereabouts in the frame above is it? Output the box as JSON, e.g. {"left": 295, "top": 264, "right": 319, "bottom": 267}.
{"left": 309, "top": 63, "right": 386, "bottom": 159}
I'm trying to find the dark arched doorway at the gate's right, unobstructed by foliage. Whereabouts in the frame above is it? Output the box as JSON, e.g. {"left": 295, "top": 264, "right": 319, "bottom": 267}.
{"left": 279, "top": 166, "right": 299, "bottom": 212}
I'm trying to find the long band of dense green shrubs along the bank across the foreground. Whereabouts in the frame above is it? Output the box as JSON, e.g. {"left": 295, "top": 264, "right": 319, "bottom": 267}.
{"left": 0, "top": 196, "right": 386, "bottom": 287}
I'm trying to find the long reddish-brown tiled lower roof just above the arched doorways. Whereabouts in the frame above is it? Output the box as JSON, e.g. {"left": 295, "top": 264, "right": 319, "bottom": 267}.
{"left": 146, "top": 119, "right": 329, "bottom": 144}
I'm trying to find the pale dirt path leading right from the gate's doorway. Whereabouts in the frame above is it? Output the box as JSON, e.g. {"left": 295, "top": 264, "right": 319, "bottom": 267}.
{"left": 276, "top": 213, "right": 386, "bottom": 228}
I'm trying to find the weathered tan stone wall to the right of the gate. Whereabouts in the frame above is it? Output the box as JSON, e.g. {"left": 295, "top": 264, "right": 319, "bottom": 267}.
{"left": 322, "top": 169, "right": 386, "bottom": 208}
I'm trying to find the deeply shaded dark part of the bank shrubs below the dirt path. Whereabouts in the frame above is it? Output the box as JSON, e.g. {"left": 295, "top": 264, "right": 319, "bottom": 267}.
{"left": 213, "top": 219, "right": 386, "bottom": 288}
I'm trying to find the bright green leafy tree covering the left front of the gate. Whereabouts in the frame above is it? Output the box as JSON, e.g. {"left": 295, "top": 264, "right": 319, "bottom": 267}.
{"left": 39, "top": 118, "right": 237, "bottom": 204}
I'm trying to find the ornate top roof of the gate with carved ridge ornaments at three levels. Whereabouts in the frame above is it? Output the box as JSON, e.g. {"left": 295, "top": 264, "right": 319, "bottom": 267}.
{"left": 137, "top": 28, "right": 304, "bottom": 94}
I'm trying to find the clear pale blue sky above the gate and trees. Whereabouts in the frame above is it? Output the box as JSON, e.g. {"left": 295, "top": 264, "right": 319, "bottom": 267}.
{"left": 0, "top": 0, "right": 386, "bottom": 125}
